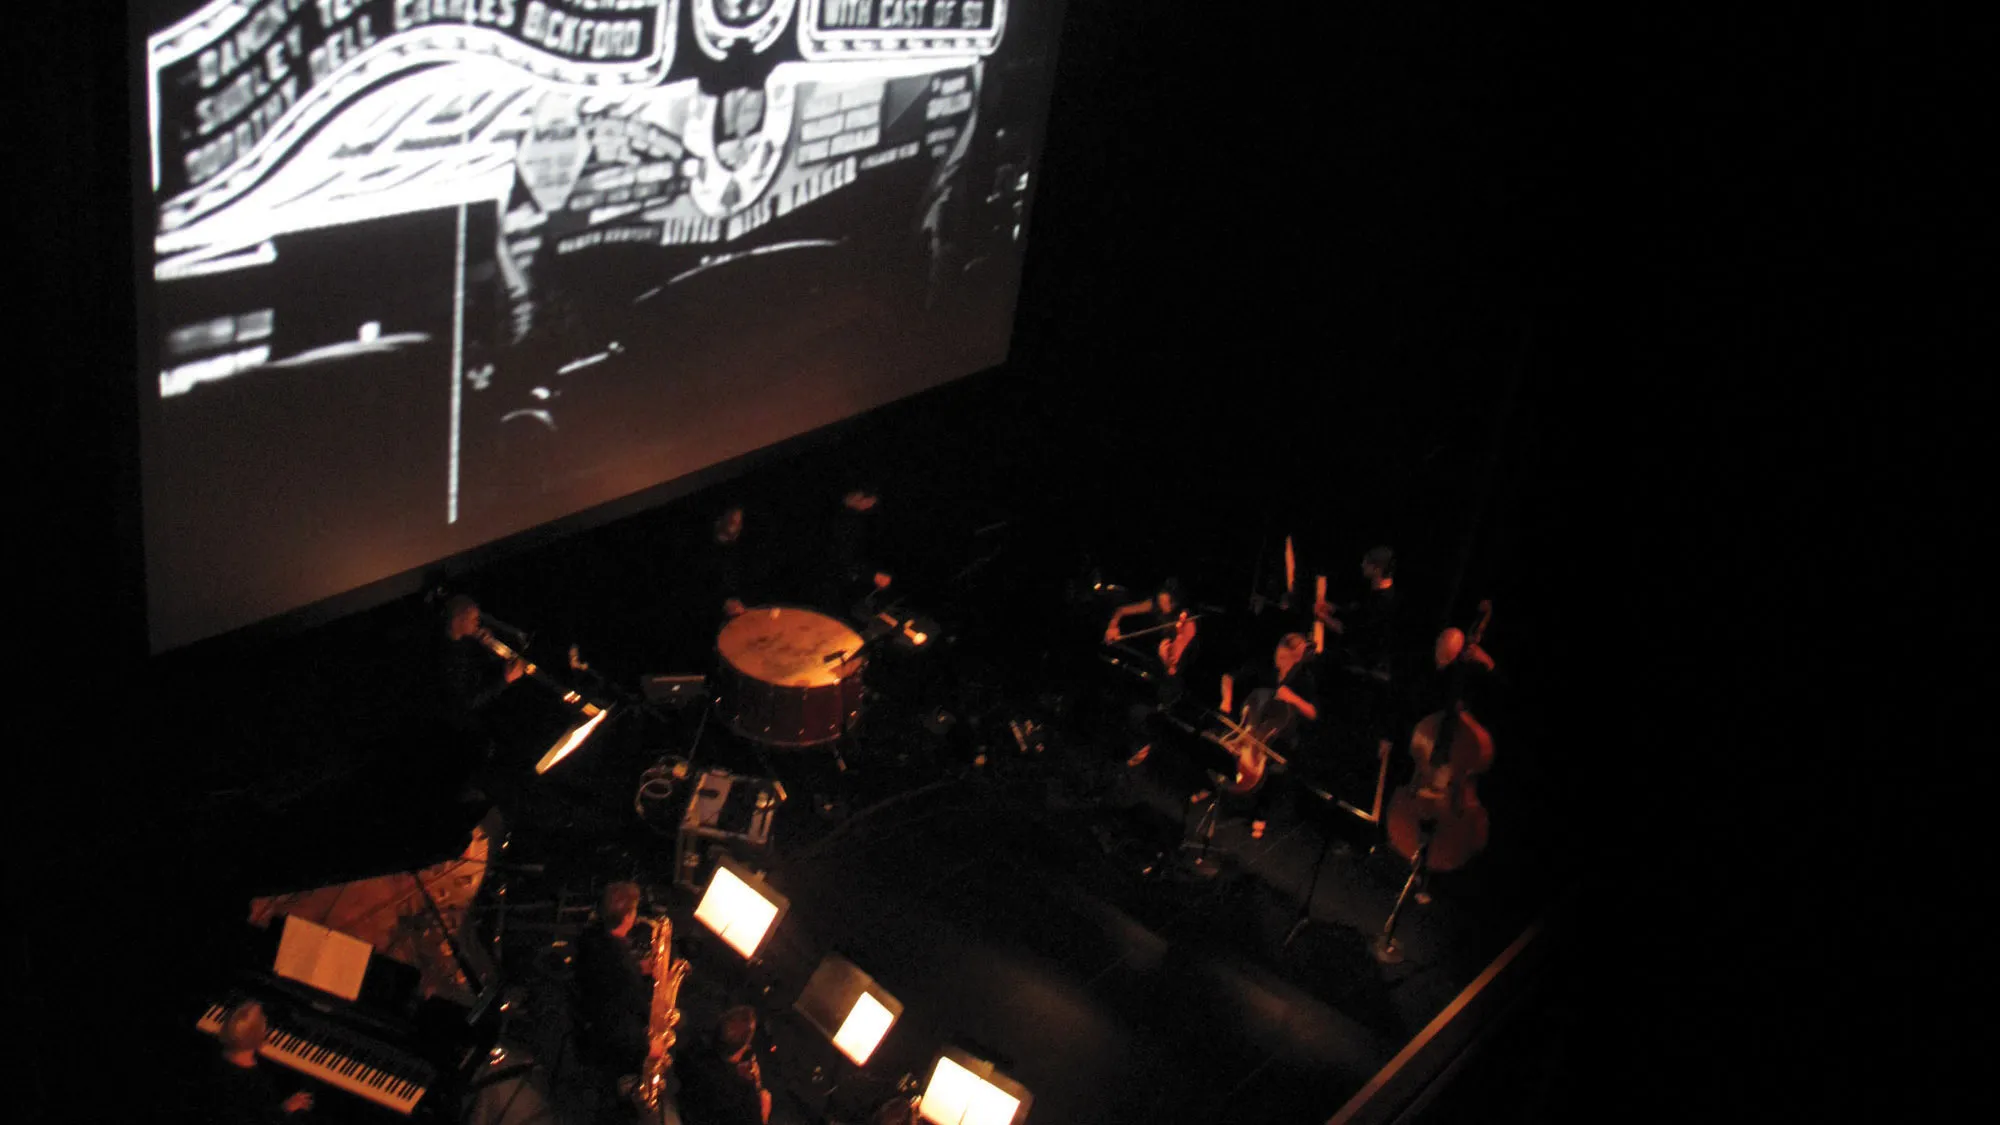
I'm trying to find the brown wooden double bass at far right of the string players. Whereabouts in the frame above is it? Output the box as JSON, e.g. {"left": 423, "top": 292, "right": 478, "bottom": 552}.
{"left": 1388, "top": 603, "right": 1494, "bottom": 871}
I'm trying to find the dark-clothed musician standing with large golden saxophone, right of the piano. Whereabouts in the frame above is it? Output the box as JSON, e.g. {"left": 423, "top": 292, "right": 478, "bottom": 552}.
{"left": 576, "top": 883, "right": 652, "bottom": 1083}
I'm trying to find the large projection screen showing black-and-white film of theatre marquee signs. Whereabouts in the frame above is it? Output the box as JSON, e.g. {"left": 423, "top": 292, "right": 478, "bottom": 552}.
{"left": 138, "top": 0, "right": 1056, "bottom": 651}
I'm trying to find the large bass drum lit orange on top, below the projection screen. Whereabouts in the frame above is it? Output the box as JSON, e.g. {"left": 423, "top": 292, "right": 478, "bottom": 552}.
{"left": 716, "top": 607, "right": 866, "bottom": 747}
